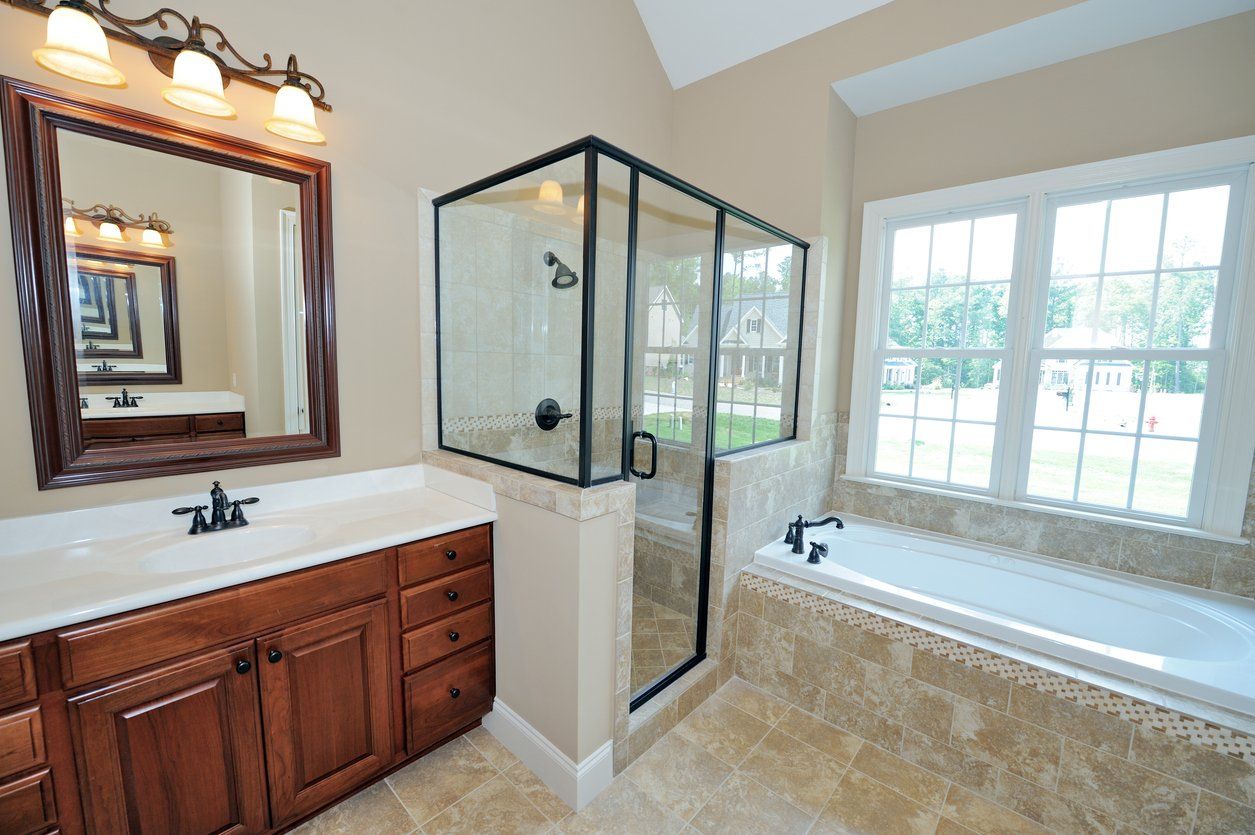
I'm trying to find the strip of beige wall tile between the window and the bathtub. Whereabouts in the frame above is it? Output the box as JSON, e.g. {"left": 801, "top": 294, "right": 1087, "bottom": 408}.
{"left": 832, "top": 412, "right": 1255, "bottom": 598}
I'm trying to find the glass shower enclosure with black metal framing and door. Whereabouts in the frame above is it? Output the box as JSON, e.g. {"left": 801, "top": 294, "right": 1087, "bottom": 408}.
{"left": 434, "top": 137, "right": 807, "bottom": 709}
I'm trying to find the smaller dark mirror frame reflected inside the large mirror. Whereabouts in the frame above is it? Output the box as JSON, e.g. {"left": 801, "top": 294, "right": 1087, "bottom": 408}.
{"left": 74, "top": 244, "right": 183, "bottom": 385}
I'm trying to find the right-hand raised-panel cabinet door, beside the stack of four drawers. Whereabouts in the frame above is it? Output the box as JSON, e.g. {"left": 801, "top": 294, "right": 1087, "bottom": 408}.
{"left": 257, "top": 600, "right": 393, "bottom": 826}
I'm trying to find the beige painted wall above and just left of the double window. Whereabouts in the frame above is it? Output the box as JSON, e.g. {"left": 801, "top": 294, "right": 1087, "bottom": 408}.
{"left": 840, "top": 4, "right": 1255, "bottom": 409}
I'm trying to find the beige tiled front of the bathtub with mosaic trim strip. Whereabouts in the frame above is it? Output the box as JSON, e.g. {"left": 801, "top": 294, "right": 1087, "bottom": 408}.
{"left": 732, "top": 569, "right": 1255, "bottom": 834}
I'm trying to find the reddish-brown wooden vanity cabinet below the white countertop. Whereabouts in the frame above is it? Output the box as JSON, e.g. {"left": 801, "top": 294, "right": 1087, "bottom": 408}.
{"left": 15, "top": 525, "right": 494, "bottom": 835}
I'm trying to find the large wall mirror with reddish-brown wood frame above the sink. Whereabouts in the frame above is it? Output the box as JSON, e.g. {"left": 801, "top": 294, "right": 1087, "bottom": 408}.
{"left": 0, "top": 77, "right": 340, "bottom": 490}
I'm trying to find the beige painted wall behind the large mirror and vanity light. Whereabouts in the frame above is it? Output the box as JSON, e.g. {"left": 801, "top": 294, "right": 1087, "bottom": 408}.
{"left": 0, "top": 0, "right": 671, "bottom": 516}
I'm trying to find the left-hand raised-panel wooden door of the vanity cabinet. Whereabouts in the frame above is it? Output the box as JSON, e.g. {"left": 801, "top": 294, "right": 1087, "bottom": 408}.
{"left": 69, "top": 644, "right": 266, "bottom": 835}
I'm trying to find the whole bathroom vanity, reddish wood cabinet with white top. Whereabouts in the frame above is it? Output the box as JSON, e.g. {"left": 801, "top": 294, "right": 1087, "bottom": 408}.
{"left": 0, "top": 467, "right": 494, "bottom": 835}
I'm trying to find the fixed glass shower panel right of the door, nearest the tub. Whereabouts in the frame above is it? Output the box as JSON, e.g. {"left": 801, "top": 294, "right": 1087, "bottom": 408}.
{"left": 714, "top": 217, "right": 806, "bottom": 451}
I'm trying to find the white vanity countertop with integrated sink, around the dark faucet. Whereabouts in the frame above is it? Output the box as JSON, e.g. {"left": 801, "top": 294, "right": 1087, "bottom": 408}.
{"left": 0, "top": 465, "right": 497, "bottom": 640}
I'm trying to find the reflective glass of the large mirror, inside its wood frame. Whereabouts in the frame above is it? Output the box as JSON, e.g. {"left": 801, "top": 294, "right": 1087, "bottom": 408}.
{"left": 56, "top": 128, "right": 309, "bottom": 448}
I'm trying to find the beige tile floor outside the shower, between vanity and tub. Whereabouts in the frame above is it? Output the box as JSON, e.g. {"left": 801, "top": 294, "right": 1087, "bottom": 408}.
{"left": 297, "top": 678, "right": 1047, "bottom": 835}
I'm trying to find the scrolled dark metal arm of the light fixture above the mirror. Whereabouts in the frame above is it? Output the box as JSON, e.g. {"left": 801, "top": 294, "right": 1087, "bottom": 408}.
{"left": 0, "top": 0, "right": 331, "bottom": 110}
